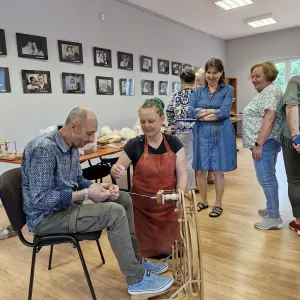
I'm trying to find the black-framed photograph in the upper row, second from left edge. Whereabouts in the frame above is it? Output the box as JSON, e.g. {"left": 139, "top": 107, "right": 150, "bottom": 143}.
{"left": 16, "top": 33, "right": 48, "bottom": 60}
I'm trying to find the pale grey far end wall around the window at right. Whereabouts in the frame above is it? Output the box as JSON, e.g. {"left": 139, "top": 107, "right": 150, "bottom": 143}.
{"left": 226, "top": 27, "right": 300, "bottom": 111}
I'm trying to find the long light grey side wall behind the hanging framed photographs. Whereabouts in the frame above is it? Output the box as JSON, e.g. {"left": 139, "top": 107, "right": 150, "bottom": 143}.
{"left": 0, "top": 0, "right": 226, "bottom": 165}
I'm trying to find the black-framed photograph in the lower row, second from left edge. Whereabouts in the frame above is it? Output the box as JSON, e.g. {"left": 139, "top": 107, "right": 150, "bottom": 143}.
{"left": 22, "top": 70, "right": 52, "bottom": 94}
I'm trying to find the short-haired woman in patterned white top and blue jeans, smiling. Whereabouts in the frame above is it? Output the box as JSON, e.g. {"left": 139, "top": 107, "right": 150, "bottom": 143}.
{"left": 243, "top": 62, "right": 284, "bottom": 230}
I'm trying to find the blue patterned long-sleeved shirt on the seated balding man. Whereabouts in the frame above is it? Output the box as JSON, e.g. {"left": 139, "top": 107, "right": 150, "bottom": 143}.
{"left": 22, "top": 130, "right": 92, "bottom": 230}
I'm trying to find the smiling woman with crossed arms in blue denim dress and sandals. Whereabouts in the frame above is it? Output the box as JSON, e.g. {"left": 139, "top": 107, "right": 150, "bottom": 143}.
{"left": 188, "top": 58, "right": 237, "bottom": 217}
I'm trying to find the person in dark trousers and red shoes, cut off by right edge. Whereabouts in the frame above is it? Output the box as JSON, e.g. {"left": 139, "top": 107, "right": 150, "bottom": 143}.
{"left": 282, "top": 76, "right": 300, "bottom": 235}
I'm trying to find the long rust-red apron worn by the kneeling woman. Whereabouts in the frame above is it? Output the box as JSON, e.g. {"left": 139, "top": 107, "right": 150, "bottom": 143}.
{"left": 131, "top": 135, "right": 179, "bottom": 257}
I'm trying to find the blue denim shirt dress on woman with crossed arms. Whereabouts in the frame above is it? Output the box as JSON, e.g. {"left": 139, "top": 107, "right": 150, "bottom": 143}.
{"left": 188, "top": 83, "right": 237, "bottom": 172}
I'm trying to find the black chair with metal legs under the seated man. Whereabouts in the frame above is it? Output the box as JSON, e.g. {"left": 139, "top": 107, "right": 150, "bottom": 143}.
{"left": 0, "top": 168, "right": 105, "bottom": 300}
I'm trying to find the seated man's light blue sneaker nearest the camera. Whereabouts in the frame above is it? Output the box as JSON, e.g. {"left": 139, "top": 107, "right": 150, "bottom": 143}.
{"left": 128, "top": 270, "right": 174, "bottom": 297}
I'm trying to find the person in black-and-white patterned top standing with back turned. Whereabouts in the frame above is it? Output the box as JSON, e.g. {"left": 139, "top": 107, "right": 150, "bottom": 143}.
{"left": 166, "top": 69, "right": 196, "bottom": 190}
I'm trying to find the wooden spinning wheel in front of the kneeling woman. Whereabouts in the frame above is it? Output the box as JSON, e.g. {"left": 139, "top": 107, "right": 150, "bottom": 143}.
{"left": 134, "top": 190, "right": 204, "bottom": 300}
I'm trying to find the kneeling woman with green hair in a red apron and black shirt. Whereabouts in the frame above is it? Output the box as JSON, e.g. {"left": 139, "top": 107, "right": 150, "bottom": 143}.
{"left": 111, "top": 98, "right": 187, "bottom": 257}
